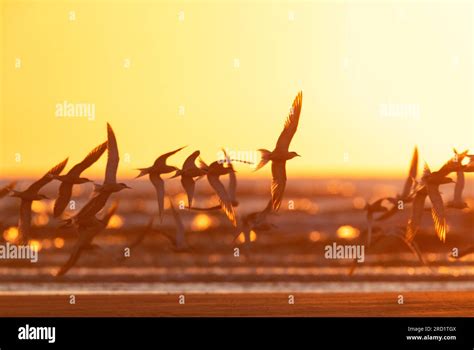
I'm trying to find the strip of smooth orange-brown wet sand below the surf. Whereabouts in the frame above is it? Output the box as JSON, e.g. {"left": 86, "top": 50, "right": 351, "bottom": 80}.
{"left": 0, "top": 292, "right": 474, "bottom": 317}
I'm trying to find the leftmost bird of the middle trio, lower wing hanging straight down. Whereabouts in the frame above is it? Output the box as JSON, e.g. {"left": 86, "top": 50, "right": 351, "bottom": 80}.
{"left": 136, "top": 147, "right": 184, "bottom": 222}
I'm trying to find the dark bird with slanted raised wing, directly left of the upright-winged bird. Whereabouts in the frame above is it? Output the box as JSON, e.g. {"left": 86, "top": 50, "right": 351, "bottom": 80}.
{"left": 51, "top": 141, "right": 107, "bottom": 217}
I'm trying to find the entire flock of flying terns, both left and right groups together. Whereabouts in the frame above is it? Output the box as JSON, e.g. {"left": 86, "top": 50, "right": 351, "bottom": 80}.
{"left": 0, "top": 92, "right": 474, "bottom": 276}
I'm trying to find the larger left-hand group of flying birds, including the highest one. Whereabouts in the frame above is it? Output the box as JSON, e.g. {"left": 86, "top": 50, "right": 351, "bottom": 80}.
{"left": 0, "top": 92, "right": 303, "bottom": 276}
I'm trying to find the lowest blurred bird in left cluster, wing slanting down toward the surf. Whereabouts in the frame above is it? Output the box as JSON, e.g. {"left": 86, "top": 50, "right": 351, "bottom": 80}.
{"left": 56, "top": 202, "right": 118, "bottom": 277}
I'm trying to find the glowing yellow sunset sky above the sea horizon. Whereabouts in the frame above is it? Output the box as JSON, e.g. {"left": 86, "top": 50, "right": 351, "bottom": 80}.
{"left": 0, "top": 0, "right": 474, "bottom": 177}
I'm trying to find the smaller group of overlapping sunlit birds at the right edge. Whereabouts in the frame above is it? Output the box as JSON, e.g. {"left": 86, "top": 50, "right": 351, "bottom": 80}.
{"left": 356, "top": 147, "right": 474, "bottom": 274}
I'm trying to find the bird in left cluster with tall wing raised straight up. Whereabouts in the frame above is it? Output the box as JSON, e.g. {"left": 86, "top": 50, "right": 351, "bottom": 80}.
{"left": 62, "top": 123, "right": 130, "bottom": 227}
